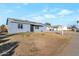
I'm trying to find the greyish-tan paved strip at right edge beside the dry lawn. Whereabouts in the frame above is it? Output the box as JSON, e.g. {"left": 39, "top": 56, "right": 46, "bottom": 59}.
{"left": 59, "top": 33, "right": 79, "bottom": 56}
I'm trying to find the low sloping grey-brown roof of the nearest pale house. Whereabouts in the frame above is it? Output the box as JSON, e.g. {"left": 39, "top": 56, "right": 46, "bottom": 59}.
{"left": 6, "top": 18, "right": 44, "bottom": 25}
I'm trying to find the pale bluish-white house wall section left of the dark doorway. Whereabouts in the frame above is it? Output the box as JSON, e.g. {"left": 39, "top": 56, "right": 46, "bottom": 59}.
{"left": 8, "top": 22, "right": 30, "bottom": 33}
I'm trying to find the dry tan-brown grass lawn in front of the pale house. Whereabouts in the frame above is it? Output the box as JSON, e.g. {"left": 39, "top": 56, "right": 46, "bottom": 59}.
{"left": 6, "top": 32, "right": 72, "bottom": 56}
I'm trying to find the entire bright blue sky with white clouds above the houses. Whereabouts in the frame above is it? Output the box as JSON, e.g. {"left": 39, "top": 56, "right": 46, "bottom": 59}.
{"left": 0, "top": 3, "right": 79, "bottom": 26}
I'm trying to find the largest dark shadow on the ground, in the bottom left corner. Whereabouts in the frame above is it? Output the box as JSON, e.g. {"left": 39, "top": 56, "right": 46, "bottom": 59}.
{"left": 0, "top": 42, "right": 18, "bottom": 56}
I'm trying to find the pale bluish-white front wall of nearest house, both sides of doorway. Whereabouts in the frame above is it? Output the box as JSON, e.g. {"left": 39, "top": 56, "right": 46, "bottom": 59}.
{"left": 8, "top": 22, "right": 46, "bottom": 33}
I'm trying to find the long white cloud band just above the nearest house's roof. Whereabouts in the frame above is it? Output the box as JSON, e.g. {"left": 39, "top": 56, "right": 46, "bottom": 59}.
{"left": 20, "top": 14, "right": 56, "bottom": 23}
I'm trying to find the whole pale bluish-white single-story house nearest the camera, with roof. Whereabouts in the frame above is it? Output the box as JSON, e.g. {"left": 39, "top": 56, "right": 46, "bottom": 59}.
{"left": 6, "top": 18, "right": 46, "bottom": 33}
